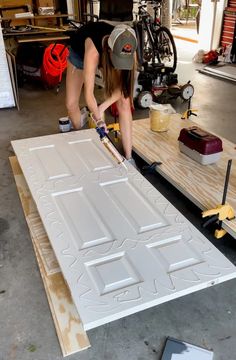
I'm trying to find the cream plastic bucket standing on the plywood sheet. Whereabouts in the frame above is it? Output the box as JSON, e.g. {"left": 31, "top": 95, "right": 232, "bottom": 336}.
{"left": 149, "top": 104, "right": 175, "bottom": 132}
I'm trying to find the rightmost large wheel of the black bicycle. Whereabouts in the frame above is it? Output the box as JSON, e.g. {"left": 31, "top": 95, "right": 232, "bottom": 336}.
{"left": 155, "top": 26, "right": 177, "bottom": 72}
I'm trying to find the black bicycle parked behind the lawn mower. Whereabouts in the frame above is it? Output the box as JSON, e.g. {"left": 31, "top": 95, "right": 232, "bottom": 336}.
{"left": 133, "top": 0, "right": 177, "bottom": 73}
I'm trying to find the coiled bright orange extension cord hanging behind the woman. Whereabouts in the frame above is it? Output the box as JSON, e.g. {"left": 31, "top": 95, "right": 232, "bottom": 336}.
{"left": 42, "top": 44, "right": 69, "bottom": 87}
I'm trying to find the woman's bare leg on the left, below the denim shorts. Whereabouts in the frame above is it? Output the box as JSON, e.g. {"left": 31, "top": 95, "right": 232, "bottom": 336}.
{"left": 66, "top": 60, "right": 84, "bottom": 129}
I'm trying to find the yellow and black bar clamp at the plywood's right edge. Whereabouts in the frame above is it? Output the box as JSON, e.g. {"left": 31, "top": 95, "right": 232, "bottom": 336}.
{"left": 202, "top": 159, "right": 235, "bottom": 239}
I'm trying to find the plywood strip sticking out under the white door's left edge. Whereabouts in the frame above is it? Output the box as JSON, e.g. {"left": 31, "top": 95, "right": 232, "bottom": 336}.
{"left": 9, "top": 156, "right": 90, "bottom": 356}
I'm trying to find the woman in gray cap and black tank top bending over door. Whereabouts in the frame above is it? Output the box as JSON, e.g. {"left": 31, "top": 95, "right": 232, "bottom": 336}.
{"left": 66, "top": 21, "right": 137, "bottom": 159}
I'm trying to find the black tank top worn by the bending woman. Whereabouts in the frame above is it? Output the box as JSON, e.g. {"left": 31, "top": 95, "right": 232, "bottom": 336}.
{"left": 70, "top": 21, "right": 114, "bottom": 59}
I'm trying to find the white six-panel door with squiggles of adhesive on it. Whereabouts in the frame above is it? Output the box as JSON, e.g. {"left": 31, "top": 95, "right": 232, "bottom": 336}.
{"left": 12, "top": 129, "right": 236, "bottom": 330}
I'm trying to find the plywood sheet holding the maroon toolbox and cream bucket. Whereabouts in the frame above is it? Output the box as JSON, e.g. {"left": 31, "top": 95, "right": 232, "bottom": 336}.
{"left": 133, "top": 114, "right": 236, "bottom": 238}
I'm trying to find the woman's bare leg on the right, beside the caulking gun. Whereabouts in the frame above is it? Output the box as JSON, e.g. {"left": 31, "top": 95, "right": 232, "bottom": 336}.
{"left": 116, "top": 96, "right": 133, "bottom": 159}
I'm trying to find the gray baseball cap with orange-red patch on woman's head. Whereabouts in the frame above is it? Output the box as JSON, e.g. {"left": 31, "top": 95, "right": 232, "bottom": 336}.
{"left": 108, "top": 24, "right": 137, "bottom": 70}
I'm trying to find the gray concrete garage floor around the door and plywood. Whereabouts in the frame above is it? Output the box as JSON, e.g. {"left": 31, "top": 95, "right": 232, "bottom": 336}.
{"left": 0, "top": 40, "right": 236, "bottom": 360}
